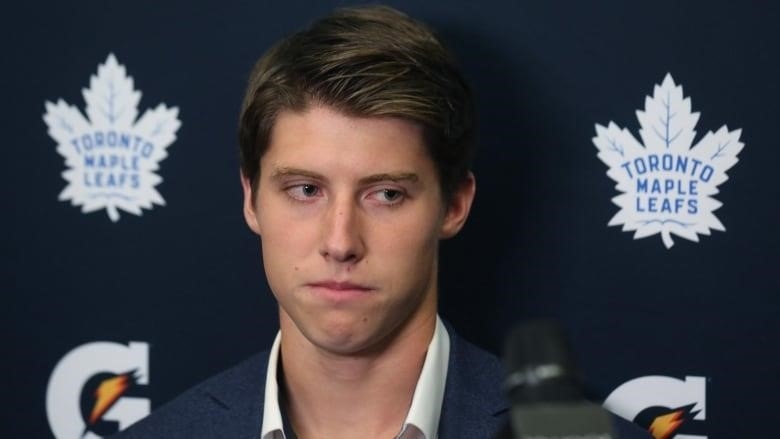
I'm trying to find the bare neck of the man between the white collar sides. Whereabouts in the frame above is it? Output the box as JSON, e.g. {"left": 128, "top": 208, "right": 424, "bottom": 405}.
{"left": 280, "top": 307, "right": 436, "bottom": 439}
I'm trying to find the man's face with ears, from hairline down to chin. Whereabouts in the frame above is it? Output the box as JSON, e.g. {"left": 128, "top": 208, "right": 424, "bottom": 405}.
{"left": 242, "top": 106, "right": 474, "bottom": 353}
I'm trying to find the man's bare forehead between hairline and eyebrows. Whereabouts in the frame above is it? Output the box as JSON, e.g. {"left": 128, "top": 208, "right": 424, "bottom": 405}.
{"left": 261, "top": 105, "right": 436, "bottom": 178}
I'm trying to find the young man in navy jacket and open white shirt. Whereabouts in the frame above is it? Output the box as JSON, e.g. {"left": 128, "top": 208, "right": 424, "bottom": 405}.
{"left": 114, "top": 7, "right": 507, "bottom": 439}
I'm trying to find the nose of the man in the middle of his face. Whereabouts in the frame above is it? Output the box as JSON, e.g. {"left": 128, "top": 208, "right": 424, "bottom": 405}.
{"left": 320, "top": 197, "right": 365, "bottom": 264}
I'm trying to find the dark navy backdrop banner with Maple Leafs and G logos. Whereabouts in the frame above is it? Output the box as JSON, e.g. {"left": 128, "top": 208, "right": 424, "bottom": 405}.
{"left": 0, "top": 0, "right": 780, "bottom": 439}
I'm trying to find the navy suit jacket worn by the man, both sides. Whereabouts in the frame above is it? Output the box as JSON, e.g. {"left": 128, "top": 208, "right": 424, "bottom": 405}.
{"left": 113, "top": 327, "right": 650, "bottom": 439}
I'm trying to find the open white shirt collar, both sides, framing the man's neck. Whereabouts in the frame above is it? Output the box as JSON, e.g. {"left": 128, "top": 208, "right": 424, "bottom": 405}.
{"left": 260, "top": 315, "right": 450, "bottom": 439}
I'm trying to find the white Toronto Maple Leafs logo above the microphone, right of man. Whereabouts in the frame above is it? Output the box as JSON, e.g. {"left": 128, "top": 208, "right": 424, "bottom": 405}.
{"left": 593, "top": 74, "right": 744, "bottom": 248}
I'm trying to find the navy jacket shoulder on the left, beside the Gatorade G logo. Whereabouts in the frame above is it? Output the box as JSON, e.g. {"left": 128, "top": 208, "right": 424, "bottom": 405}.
{"left": 113, "top": 352, "right": 268, "bottom": 439}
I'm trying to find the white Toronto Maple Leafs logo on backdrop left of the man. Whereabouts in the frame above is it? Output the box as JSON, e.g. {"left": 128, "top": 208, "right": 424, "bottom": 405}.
{"left": 43, "top": 54, "right": 181, "bottom": 222}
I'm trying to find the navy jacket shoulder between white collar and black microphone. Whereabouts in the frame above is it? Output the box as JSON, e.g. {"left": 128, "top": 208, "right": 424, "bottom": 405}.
{"left": 439, "top": 326, "right": 509, "bottom": 438}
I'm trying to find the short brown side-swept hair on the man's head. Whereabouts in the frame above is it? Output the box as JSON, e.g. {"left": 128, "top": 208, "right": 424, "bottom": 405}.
{"left": 239, "top": 6, "right": 474, "bottom": 199}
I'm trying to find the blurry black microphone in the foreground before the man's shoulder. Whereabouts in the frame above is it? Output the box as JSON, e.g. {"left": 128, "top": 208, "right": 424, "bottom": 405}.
{"left": 504, "top": 320, "right": 616, "bottom": 439}
